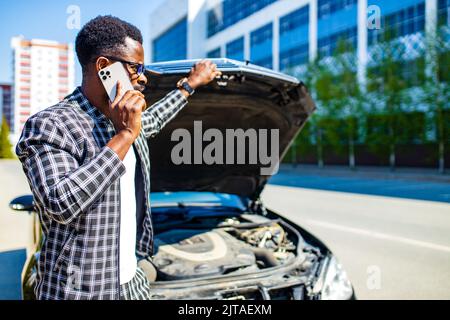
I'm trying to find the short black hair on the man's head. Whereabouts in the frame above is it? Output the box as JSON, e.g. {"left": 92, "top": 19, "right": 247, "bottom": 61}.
{"left": 75, "top": 15, "right": 142, "bottom": 71}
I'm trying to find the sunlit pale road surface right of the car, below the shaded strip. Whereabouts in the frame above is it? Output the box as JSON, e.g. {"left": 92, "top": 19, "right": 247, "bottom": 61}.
{"left": 263, "top": 185, "right": 450, "bottom": 299}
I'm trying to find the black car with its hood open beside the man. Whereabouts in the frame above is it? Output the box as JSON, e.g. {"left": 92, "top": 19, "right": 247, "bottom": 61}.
{"left": 11, "top": 59, "right": 355, "bottom": 300}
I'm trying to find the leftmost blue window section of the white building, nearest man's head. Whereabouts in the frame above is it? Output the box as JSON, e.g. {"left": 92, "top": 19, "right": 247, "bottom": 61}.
{"left": 153, "top": 18, "right": 187, "bottom": 62}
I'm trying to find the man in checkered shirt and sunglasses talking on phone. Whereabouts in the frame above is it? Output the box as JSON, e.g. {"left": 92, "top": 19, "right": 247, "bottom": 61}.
{"left": 16, "top": 16, "right": 220, "bottom": 299}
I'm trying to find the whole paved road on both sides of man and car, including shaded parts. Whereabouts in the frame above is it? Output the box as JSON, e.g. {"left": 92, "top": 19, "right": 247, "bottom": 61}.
{"left": 0, "top": 161, "right": 450, "bottom": 299}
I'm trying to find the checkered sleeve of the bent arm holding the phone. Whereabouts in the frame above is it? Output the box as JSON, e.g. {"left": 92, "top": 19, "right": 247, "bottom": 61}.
{"left": 17, "top": 116, "right": 125, "bottom": 224}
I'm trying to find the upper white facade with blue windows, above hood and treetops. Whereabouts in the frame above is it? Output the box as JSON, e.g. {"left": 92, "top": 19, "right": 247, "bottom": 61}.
{"left": 149, "top": 0, "right": 450, "bottom": 75}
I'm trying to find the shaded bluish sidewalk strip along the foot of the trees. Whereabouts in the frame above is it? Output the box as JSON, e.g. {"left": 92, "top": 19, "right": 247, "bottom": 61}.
{"left": 279, "top": 164, "right": 450, "bottom": 183}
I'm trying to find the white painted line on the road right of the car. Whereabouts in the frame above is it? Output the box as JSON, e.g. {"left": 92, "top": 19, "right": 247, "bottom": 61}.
{"left": 305, "top": 219, "right": 450, "bottom": 253}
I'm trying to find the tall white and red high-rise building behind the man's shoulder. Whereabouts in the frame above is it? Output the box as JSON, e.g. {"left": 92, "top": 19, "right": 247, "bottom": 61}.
{"left": 10, "top": 36, "right": 75, "bottom": 144}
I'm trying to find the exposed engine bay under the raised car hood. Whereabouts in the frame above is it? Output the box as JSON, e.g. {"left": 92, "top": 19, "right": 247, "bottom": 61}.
{"left": 152, "top": 213, "right": 302, "bottom": 281}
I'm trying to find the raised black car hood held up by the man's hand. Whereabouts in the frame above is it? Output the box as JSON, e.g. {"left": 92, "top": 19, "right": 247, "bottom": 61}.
{"left": 144, "top": 59, "right": 315, "bottom": 200}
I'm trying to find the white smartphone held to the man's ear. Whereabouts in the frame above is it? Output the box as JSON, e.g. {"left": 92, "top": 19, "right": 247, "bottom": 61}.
{"left": 98, "top": 62, "right": 134, "bottom": 102}
